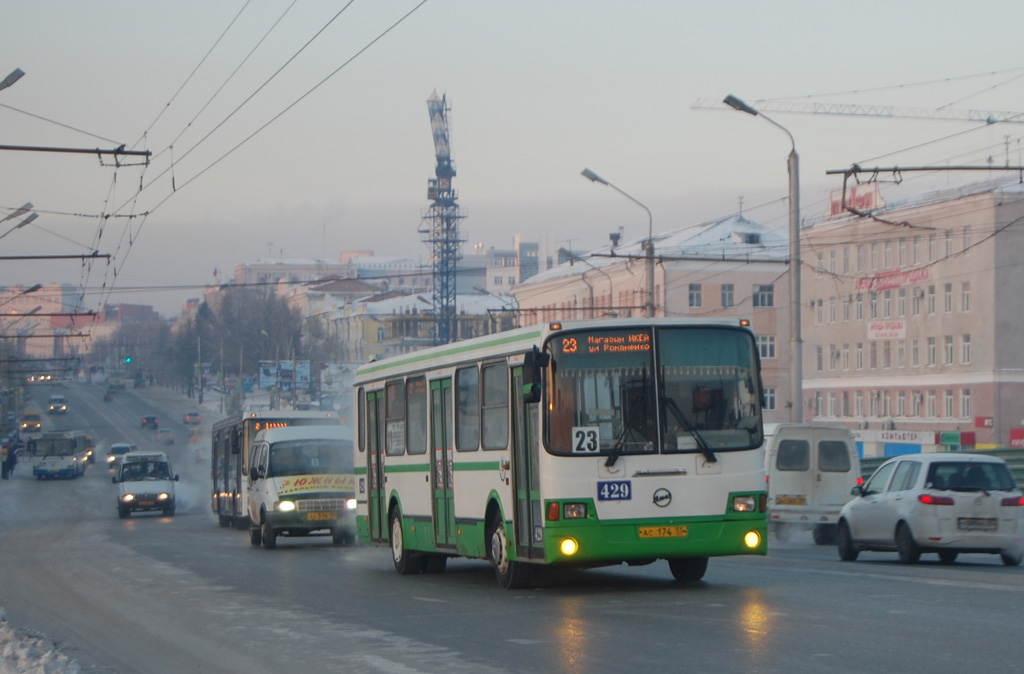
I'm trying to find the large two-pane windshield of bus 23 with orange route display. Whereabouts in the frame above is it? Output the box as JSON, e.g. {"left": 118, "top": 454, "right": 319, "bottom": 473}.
{"left": 545, "top": 326, "right": 762, "bottom": 458}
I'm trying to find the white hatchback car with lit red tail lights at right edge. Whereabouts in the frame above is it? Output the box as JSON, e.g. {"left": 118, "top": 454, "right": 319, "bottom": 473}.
{"left": 837, "top": 453, "right": 1024, "bottom": 566}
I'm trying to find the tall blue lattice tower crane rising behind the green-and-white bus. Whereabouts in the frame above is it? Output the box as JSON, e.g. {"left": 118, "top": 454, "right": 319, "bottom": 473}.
{"left": 419, "top": 89, "right": 465, "bottom": 344}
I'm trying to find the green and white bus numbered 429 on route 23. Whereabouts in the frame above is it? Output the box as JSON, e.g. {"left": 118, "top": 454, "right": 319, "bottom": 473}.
{"left": 355, "top": 319, "right": 766, "bottom": 588}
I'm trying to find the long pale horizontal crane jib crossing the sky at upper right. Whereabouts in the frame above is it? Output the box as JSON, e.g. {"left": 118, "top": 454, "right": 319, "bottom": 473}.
{"left": 690, "top": 98, "right": 1024, "bottom": 124}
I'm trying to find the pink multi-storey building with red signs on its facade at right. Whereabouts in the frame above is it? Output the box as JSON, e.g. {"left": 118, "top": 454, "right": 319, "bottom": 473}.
{"left": 802, "top": 178, "right": 1024, "bottom": 456}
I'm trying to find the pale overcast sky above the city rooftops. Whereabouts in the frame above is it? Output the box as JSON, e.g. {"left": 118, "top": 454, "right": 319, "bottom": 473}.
{"left": 0, "top": 0, "right": 1024, "bottom": 313}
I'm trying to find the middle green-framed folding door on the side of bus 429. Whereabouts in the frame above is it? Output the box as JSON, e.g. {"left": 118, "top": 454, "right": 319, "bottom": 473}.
{"left": 430, "top": 379, "right": 456, "bottom": 548}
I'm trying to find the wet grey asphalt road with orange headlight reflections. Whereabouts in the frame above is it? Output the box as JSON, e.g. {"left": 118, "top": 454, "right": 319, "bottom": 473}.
{"left": 0, "top": 384, "right": 1024, "bottom": 674}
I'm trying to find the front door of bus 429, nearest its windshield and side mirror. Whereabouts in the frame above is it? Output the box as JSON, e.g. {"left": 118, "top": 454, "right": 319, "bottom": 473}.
{"left": 512, "top": 368, "right": 544, "bottom": 559}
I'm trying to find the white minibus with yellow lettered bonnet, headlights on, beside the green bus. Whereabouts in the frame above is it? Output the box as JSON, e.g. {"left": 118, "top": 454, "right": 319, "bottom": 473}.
{"left": 248, "top": 426, "right": 355, "bottom": 550}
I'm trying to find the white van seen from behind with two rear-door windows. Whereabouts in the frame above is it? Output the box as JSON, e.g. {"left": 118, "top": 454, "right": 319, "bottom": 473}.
{"left": 765, "top": 424, "right": 863, "bottom": 545}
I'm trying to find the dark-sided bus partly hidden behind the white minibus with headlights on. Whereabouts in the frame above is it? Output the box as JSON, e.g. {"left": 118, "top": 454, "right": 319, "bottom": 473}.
{"left": 210, "top": 410, "right": 338, "bottom": 529}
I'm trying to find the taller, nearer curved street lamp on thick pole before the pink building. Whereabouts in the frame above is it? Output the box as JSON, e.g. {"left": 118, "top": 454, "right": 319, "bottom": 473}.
{"left": 724, "top": 94, "right": 804, "bottom": 422}
